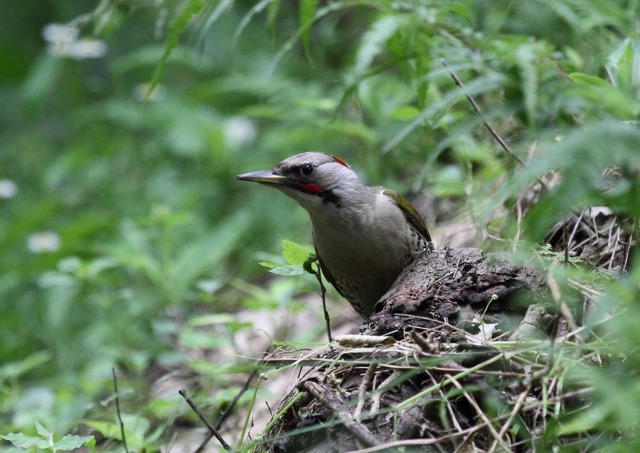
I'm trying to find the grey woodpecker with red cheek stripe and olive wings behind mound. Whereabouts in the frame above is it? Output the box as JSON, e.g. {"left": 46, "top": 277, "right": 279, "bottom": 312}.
{"left": 237, "top": 152, "right": 431, "bottom": 318}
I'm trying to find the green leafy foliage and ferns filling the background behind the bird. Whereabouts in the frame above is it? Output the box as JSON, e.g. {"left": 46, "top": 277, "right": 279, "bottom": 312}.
{"left": 0, "top": 0, "right": 640, "bottom": 448}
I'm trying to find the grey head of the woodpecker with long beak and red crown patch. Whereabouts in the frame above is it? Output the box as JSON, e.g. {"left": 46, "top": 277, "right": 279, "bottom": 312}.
{"left": 237, "top": 152, "right": 363, "bottom": 213}
